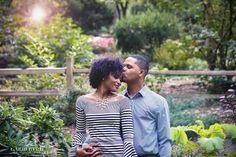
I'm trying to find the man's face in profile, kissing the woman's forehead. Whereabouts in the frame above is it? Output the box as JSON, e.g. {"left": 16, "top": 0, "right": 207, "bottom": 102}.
{"left": 122, "top": 57, "right": 143, "bottom": 83}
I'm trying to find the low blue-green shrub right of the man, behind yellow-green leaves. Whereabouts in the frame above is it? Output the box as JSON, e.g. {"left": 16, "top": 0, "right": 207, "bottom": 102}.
{"left": 167, "top": 96, "right": 222, "bottom": 127}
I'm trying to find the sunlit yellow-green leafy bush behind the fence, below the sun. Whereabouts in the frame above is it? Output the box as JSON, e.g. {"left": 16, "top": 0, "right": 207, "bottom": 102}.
{"left": 16, "top": 14, "right": 93, "bottom": 67}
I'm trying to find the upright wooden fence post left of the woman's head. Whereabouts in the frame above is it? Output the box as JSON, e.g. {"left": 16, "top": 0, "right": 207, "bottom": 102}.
{"left": 66, "top": 57, "right": 74, "bottom": 89}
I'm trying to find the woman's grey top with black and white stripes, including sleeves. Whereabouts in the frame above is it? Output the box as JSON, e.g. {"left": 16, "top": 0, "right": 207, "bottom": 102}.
{"left": 72, "top": 96, "right": 137, "bottom": 157}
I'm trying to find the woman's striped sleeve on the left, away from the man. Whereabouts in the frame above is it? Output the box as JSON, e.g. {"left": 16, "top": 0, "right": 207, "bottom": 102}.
{"left": 69, "top": 97, "right": 86, "bottom": 157}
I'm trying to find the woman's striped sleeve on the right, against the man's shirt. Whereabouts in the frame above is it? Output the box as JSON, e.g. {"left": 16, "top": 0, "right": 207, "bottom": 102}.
{"left": 121, "top": 98, "right": 137, "bottom": 157}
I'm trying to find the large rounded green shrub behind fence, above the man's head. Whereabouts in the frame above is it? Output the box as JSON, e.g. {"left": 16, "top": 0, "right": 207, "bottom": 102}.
{"left": 114, "top": 10, "right": 181, "bottom": 59}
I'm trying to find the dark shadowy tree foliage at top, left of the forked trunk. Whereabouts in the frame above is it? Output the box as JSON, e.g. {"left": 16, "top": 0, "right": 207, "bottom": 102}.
{"left": 67, "top": 0, "right": 115, "bottom": 33}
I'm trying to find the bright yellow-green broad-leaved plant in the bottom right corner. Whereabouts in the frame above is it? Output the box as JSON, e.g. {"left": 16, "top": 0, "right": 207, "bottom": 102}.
{"left": 171, "top": 121, "right": 236, "bottom": 156}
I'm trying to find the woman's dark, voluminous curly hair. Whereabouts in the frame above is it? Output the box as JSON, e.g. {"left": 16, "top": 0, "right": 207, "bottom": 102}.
{"left": 89, "top": 56, "right": 123, "bottom": 88}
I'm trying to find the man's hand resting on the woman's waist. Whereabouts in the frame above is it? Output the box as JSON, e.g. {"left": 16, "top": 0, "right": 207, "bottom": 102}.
{"left": 76, "top": 143, "right": 102, "bottom": 157}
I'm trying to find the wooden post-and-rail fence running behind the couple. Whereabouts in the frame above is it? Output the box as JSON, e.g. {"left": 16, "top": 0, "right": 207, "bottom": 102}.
{"left": 0, "top": 58, "right": 236, "bottom": 96}
